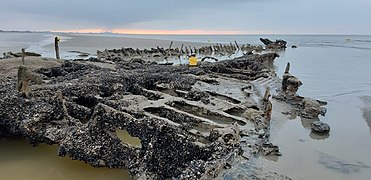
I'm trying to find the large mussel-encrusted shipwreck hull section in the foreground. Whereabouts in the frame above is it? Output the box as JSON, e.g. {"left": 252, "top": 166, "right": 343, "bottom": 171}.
{"left": 0, "top": 53, "right": 277, "bottom": 179}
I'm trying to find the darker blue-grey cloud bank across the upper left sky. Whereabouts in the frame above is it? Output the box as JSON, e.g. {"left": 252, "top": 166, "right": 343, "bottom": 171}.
{"left": 0, "top": 0, "right": 251, "bottom": 27}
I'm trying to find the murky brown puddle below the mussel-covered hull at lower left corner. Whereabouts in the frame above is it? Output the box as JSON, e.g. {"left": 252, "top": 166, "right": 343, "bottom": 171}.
{"left": 0, "top": 138, "right": 130, "bottom": 180}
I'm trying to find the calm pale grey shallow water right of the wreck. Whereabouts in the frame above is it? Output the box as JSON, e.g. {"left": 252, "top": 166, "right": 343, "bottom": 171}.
{"left": 259, "top": 37, "right": 371, "bottom": 179}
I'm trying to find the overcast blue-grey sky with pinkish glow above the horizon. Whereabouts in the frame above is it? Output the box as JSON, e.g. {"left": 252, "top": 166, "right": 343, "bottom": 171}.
{"left": 0, "top": 0, "right": 371, "bottom": 34}
